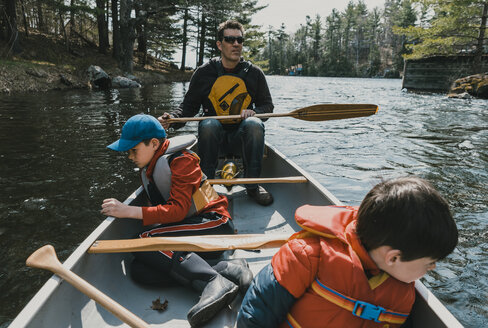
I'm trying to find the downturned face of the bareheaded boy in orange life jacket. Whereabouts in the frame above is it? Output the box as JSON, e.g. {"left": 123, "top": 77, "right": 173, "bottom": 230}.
{"left": 384, "top": 257, "right": 436, "bottom": 283}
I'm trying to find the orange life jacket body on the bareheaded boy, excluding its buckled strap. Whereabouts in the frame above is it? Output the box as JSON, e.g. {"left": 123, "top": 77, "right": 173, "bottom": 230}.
{"left": 271, "top": 205, "right": 415, "bottom": 328}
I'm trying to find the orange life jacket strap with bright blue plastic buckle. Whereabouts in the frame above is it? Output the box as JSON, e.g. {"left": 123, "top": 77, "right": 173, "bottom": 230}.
{"left": 312, "top": 279, "right": 408, "bottom": 324}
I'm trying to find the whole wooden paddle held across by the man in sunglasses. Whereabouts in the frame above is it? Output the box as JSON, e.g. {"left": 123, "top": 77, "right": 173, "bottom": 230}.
{"left": 167, "top": 104, "right": 378, "bottom": 123}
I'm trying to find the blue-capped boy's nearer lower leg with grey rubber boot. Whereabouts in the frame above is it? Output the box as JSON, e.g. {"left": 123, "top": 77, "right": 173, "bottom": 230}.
{"left": 170, "top": 252, "right": 239, "bottom": 327}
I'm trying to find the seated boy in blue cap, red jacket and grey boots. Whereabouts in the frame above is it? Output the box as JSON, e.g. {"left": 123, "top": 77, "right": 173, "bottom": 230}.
{"left": 101, "top": 114, "right": 252, "bottom": 326}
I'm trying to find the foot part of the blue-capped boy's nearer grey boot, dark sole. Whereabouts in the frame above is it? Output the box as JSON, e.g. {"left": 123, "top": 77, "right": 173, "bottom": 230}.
{"left": 187, "top": 274, "right": 239, "bottom": 327}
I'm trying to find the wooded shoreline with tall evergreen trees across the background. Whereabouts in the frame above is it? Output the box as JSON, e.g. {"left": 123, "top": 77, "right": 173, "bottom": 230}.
{"left": 0, "top": 0, "right": 488, "bottom": 95}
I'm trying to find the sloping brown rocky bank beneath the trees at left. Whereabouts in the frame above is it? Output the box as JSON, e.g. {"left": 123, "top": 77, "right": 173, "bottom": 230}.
{"left": 0, "top": 31, "right": 193, "bottom": 95}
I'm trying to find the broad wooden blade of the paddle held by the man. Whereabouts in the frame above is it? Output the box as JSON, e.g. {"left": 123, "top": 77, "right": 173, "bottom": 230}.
{"left": 290, "top": 104, "right": 378, "bottom": 121}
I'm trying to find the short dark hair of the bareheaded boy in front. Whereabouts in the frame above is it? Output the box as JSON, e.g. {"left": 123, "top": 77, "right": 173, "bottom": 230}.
{"left": 356, "top": 176, "right": 458, "bottom": 261}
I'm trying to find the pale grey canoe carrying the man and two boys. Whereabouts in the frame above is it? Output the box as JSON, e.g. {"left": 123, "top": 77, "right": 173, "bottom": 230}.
{"left": 10, "top": 144, "right": 462, "bottom": 328}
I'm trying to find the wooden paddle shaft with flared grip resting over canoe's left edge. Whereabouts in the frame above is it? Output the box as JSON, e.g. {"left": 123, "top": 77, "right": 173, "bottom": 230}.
{"left": 26, "top": 245, "right": 149, "bottom": 328}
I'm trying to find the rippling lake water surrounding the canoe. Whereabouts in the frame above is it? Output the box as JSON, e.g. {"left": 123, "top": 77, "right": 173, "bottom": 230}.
{"left": 0, "top": 76, "right": 488, "bottom": 328}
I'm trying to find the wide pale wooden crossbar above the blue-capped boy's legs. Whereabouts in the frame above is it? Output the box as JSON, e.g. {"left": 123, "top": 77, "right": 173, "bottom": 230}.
{"left": 88, "top": 234, "right": 290, "bottom": 253}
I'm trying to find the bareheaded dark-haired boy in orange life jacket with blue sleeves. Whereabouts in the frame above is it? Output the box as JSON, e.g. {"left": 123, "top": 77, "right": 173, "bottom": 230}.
{"left": 237, "top": 177, "right": 458, "bottom": 328}
